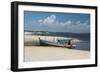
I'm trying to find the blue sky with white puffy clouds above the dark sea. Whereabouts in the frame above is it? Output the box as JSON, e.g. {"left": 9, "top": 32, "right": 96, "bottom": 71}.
{"left": 24, "top": 11, "right": 90, "bottom": 33}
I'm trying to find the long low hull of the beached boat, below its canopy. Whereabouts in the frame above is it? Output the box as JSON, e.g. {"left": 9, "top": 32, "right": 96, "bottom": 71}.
{"left": 39, "top": 38, "right": 76, "bottom": 48}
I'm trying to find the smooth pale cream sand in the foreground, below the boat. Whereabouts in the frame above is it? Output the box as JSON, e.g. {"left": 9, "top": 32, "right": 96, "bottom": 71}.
{"left": 24, "top": 46, "right": 90, "bottom": 62}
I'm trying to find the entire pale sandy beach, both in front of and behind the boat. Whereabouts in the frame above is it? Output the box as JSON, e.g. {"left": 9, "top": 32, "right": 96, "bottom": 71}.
{"left": 24, "top": 33, "right": 90, "bottom": 62}
